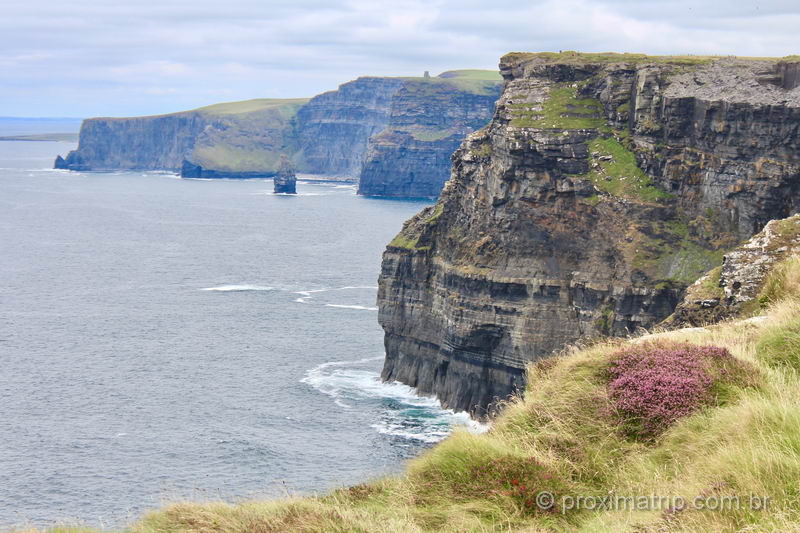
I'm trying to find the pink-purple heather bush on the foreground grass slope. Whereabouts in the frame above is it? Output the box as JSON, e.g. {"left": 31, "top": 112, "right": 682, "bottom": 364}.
{"left": 609, "top": 343, "right": 736, "bottom": 438}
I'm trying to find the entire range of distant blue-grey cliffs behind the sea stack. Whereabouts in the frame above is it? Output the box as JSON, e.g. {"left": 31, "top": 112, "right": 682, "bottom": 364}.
{"left": 55, "top": 70, "right": 502, "bottom": 197}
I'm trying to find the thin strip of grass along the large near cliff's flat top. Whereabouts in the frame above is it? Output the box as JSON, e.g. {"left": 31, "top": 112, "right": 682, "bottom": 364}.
{"left": 501, "top": 50, "right": 796, "bottom": 65}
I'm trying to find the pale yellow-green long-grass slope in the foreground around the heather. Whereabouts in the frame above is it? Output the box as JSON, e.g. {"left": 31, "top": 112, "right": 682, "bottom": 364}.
{"left": 37, "top": 258, "right": 800, "bottom": 533}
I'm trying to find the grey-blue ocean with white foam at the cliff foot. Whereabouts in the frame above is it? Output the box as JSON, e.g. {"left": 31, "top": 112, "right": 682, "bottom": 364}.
{"left": 0, "top": 135, "right": 481, "bottom": 529}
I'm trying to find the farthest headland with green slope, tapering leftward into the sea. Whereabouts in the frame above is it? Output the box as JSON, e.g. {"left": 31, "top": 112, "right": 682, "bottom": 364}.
{"left": 56, "top": 99, "right": 307, "bottom": 175}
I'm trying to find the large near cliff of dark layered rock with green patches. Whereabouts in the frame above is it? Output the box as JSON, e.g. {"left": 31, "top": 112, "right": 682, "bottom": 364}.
{"left": 378, "top": 53, "right": 800, "bottom": 416}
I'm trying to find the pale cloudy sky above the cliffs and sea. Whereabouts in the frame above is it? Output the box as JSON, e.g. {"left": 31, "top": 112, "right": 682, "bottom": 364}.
{"left": 0, "top": 0, "right": 800, "bottom": 117}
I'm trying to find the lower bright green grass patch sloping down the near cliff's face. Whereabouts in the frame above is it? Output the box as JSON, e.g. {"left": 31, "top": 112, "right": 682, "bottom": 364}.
{"left": 588, "top": 136, "right": 671, "bottom": 202}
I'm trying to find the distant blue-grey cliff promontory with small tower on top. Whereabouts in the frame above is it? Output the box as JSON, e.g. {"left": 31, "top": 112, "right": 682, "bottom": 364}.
{"left": 358, "top": 77, "right": 502, "bottom": 197}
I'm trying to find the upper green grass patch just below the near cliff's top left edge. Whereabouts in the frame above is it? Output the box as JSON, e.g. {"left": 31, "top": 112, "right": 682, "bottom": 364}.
{"left": 508, "top": 87, "right": 605, "bottom": 129}
